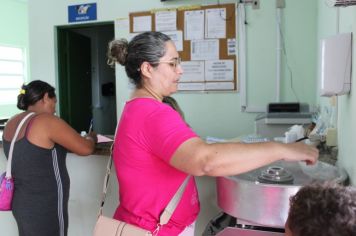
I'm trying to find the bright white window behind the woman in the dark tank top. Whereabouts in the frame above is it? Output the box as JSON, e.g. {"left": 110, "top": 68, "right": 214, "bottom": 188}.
{"left": 0, "top": 45, "right": 26, "bottom": 105}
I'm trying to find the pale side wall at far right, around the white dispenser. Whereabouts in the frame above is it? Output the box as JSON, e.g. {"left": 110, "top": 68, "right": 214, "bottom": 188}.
{"left": 318, "top": 0, "right": 356, "bottom": 185}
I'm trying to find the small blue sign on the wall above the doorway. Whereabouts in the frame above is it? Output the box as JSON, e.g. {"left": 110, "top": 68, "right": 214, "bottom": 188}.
{"left": 68, "top": 3, "right": 96, "bottom": 23}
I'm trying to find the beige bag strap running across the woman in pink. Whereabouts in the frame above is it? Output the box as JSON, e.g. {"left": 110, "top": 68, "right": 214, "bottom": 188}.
{"left": 99, "top": 152, "right": 191, "bottom": 226}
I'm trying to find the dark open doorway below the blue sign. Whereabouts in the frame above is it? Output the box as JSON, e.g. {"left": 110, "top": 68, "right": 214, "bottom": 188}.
{"left": 57, "top": 22, "right": 117, "bottom": 135}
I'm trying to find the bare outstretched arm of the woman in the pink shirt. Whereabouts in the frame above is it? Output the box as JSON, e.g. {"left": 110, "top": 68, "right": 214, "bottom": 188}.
{"left": 170, "top": 138, "right": 318, "bottom": 176}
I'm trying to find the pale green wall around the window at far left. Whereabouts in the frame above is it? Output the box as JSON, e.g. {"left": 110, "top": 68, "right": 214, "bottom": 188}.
{"left": 0, "top": 0, "right": 29, "bottom": 117}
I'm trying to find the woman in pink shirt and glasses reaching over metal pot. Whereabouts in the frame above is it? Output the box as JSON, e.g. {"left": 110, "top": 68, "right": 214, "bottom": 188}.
{"left": 108, "top": 32, "right": 318, "bottom": 236}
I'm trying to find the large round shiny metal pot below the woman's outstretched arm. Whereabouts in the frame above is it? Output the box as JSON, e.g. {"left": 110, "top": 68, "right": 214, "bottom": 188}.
{"left": 217, "top": 161, "right": 347, "bottom": 228}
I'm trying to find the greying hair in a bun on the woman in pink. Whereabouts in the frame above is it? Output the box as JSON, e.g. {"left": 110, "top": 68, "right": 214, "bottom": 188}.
{"left": 107, "top": 32, "right": 171, "bottom": 88}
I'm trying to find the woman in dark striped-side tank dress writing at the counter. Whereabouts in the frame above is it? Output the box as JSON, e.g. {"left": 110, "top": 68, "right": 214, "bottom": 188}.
{"left": 3, "top": 80, "right": 97, "bottom": 236}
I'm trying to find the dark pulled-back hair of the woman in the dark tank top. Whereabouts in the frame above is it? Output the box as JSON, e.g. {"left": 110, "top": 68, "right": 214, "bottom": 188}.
{"left": 17, "top": 80, "right": 56, "bottom": 110}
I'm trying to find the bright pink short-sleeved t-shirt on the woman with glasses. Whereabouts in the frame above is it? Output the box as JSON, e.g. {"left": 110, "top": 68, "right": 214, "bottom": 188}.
{"left": 114, "top": 98, "right": 200, "bottom": 236}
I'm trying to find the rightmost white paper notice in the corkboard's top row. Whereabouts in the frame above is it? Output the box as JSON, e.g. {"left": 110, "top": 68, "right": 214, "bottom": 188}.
{"left": 205, "top": 8, "right": 226, "bottom": 39}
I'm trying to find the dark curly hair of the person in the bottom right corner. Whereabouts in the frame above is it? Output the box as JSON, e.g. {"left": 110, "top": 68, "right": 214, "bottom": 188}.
{"left": 286, "top": 182, "right": 356, "bottom": 236}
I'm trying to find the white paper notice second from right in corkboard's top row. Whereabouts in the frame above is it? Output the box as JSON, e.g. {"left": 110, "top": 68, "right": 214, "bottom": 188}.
{"left": 184, "top": 10, "right": 204, "bottom": 40}
